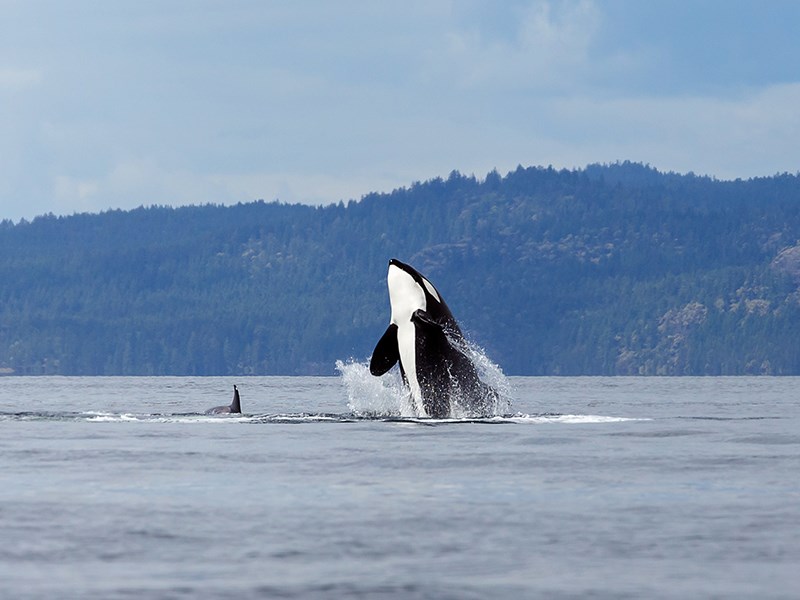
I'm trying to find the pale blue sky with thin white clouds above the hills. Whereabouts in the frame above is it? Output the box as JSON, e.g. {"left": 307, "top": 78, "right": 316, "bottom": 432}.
{"left": 0, "top": 0, "right": 800, "bottom": 222}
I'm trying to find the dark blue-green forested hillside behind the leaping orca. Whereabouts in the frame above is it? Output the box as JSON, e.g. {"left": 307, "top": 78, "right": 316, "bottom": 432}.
{"left": 0, "top": 163, "right": 800, "bottom": 375}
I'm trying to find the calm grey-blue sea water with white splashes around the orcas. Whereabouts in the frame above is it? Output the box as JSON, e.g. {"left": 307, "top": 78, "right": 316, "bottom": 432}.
{"left": 0, "top": 372, "right": 800, "bottom": 599}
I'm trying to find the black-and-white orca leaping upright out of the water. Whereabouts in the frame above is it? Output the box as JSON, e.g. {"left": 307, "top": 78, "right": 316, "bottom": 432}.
{"left": 369, "top": 259, "right": 497, "bottom": 419}
